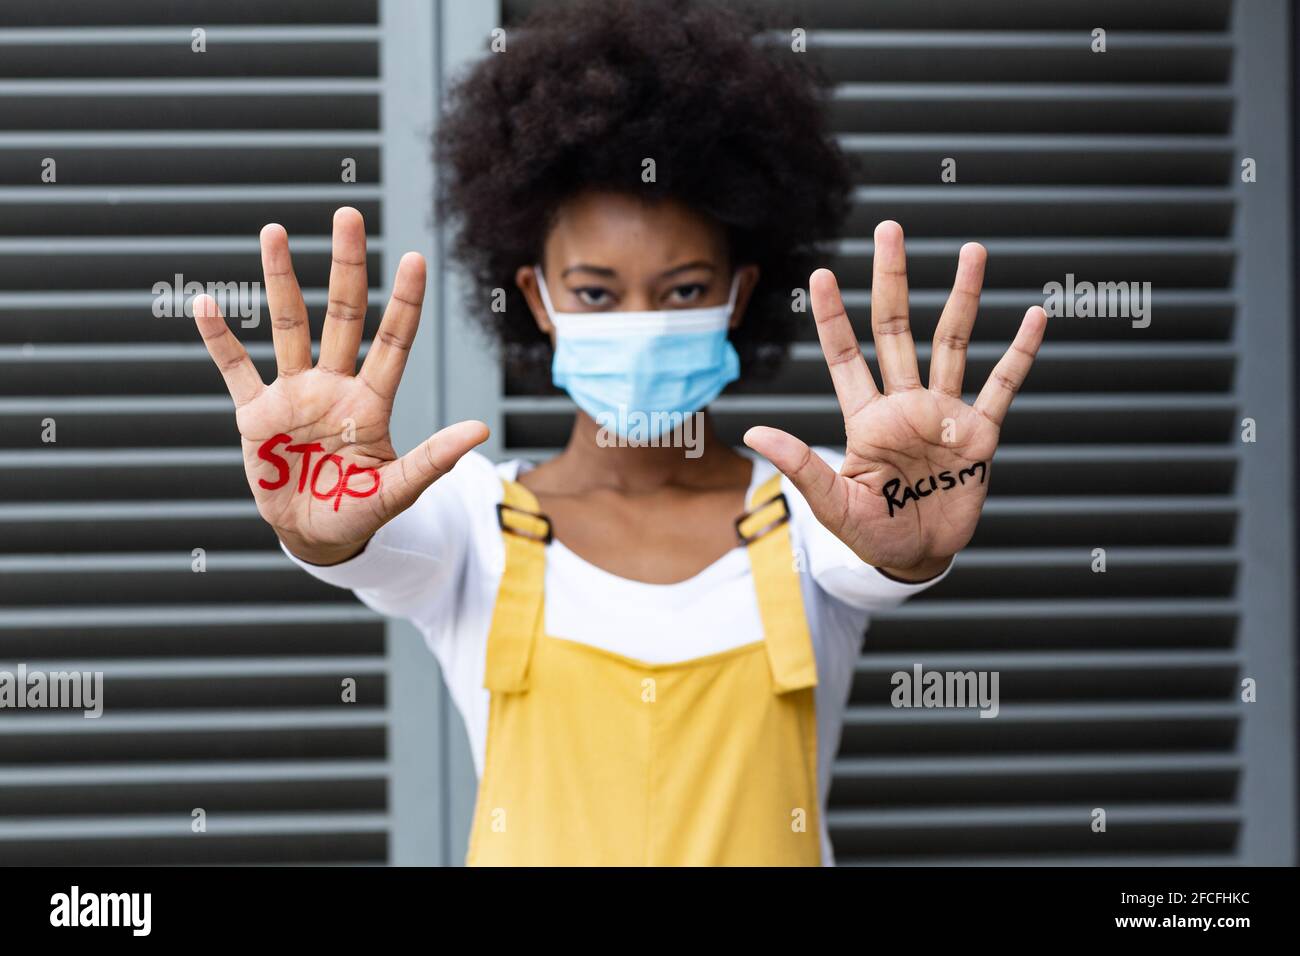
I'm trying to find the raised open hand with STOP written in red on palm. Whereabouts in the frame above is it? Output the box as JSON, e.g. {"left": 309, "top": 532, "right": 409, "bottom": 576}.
{"left": 194, "top": 208, "right": 488, "bottom": 564}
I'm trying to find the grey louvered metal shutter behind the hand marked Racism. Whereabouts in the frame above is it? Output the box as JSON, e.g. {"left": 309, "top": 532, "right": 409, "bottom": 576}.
{"left": 483, "top": 0, "right": 1295, "bottom": 864}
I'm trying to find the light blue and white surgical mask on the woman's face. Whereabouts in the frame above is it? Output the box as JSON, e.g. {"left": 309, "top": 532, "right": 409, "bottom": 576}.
{"left": 533, "top": 265, "right": 740, "bottom": 440}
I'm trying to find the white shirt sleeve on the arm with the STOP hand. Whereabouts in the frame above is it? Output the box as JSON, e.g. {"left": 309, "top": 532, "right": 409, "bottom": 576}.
{"left": 280, "top": 451, "right": 497, "bottom": 627}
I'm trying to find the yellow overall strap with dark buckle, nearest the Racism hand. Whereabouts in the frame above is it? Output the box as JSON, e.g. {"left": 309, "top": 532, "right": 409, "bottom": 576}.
{"left": 736, "top": 472, "right": 816, "bottom": 693}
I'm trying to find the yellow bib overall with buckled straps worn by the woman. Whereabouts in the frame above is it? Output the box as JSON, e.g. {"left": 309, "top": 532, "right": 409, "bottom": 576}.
{"left": 467, "top": 475, "right": 822, "bottom": 866}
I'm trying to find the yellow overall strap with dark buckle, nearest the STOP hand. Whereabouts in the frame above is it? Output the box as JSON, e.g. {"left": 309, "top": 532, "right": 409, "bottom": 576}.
{"left": 484, "top": 479, "right": 551, "bottom": 693}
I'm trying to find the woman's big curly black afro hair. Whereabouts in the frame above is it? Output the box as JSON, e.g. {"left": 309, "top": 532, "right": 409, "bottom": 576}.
{"left": 438, "top": 0, "right": 850, "bottom": 386}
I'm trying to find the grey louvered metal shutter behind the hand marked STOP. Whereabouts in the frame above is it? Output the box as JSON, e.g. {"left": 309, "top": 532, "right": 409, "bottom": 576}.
{"left": 0, "top": 0, "right": 436, "bottom": 864}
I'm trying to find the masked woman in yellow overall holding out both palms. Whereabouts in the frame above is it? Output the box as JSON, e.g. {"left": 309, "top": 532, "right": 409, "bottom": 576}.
{"left": 194, "top": 0, "right": 1047, "bottom": 865}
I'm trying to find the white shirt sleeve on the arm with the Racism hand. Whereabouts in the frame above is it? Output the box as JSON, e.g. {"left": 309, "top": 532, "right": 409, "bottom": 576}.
{"left": 781, "top": 447, "right": 957, "bottom": 611}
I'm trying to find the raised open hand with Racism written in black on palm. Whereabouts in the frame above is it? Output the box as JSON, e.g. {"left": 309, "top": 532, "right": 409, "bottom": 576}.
{"left": 745, "top": 222, "right": 1047, "bottom": 580}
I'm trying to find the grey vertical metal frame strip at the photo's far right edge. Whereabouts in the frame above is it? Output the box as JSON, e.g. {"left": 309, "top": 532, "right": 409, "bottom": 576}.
{"left": 1232, "top": 0, "right": 1296, "bottom": 866}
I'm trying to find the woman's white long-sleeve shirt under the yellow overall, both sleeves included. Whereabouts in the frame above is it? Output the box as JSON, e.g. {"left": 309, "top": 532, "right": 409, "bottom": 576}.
{"left": 285, "top": 447, "right": 952, "bottom": 864}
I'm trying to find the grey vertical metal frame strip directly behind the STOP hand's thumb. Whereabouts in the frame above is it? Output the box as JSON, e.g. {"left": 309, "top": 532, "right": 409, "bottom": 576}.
{"left": 371, "top": 0, "right": 447, "bottom": 866}
